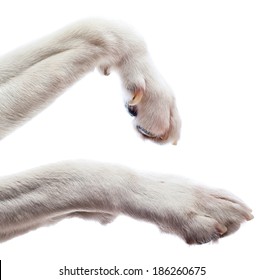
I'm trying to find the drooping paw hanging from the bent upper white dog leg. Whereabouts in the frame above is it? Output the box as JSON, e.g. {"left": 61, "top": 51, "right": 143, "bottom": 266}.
{"left": 118, "top": 56, "right": 181, "bottom": 144}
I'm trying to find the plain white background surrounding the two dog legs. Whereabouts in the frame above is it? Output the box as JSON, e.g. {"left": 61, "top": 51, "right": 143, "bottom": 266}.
{"left": 0, "top": 0, "right": 263, "bottom": 280}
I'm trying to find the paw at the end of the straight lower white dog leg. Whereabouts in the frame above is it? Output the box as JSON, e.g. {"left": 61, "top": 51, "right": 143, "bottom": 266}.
{"left": 159, "top": 188, "right": 253, "bottom": 244}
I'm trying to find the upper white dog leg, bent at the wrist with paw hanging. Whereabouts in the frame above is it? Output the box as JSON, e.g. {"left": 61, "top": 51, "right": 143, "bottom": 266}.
{"left": 0, "top": 20, "right": 180, "bottom": 142}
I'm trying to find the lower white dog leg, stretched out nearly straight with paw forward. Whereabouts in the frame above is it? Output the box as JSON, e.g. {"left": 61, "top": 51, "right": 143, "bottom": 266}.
{"left": 0, "top": 161, "right": 253, "bottom": 244}
